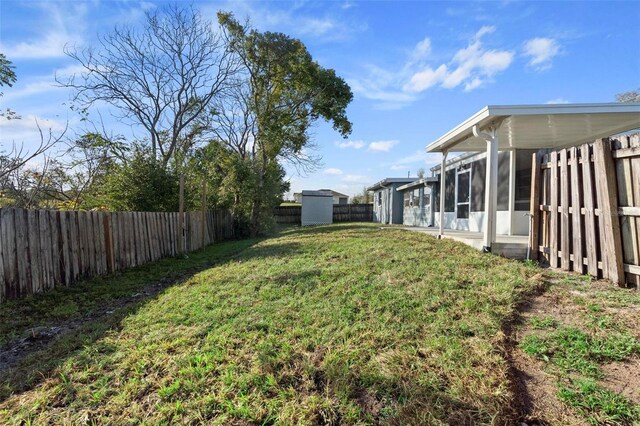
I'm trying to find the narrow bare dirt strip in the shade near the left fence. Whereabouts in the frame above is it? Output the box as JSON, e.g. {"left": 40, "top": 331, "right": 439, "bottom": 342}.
{"left": 0, "top": 271, "right": 201, "bottom": 376}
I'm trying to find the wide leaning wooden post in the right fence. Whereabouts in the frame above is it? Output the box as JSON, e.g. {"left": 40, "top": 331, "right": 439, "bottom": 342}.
{"left": 593, "top": 138, "right": 625, "bottom": 285}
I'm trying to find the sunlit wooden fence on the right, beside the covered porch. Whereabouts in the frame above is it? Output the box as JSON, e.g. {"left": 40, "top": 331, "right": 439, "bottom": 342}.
{"left": 529, "top": 135, "right": 640, "bottom": 285}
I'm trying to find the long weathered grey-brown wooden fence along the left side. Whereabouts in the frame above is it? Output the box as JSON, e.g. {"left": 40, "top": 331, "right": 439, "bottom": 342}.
{"left": 0, "top": 208, "right": 233, "bottom": 302}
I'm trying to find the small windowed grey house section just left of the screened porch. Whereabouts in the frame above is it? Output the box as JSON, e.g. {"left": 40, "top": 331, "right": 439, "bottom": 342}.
{"left": 396, "top": 177, "right": 438, "bottom": 226}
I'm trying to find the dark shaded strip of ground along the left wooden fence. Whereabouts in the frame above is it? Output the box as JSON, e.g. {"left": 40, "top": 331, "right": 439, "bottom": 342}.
{"left": 0, "top": 239, "right": 298, "bottom": 401}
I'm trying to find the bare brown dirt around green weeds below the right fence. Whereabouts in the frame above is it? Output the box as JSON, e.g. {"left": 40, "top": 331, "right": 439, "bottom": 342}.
{"left": 503, "top": 273, "right": 640, "bottom": 426}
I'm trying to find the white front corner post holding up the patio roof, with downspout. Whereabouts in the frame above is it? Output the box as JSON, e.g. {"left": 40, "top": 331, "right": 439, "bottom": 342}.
{"left": 473, "top": 125, "right": 498, "bottom": 253}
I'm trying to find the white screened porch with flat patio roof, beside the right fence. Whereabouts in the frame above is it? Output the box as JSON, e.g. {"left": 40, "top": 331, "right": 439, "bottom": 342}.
{"left": 427, "top": 103, "right": 640, "bottom": 251}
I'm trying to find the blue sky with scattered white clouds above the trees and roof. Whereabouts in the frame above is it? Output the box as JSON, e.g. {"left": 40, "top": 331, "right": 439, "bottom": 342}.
{"left": 0, "top": 0, "right": 640, "bottom": 198}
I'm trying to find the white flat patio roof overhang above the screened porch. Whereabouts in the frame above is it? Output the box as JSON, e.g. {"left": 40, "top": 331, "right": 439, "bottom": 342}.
{"left": 427, "top": 102, "right": 640, "bottom": 152}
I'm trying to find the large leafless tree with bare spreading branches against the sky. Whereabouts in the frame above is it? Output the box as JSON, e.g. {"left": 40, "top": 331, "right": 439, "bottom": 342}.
{"left": 58, "top": 5, "right": 237, "bottom": 166}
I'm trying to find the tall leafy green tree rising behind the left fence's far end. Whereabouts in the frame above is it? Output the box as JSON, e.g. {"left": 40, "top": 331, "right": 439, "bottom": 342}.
{"left": 218, "top": 12, "right": 353, "bottom": 235}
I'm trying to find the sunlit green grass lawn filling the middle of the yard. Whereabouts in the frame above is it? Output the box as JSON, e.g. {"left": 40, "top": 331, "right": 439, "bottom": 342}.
{"left": 0, "top": 224, "right": 539, "bottom": 425}
